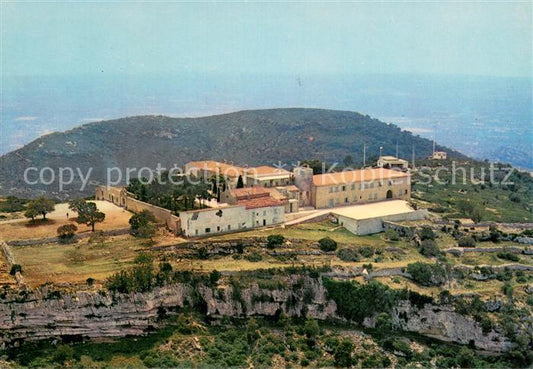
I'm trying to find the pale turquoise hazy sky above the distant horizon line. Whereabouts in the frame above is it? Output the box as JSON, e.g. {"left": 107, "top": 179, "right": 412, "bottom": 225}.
{"left": 1, "top": 0, "right": 532, "bottom": 77}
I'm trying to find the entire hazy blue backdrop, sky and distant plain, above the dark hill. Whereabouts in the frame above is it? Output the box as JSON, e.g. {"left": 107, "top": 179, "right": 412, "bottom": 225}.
{"left": 0, "top": 2, "right": 533, "bottom": 168}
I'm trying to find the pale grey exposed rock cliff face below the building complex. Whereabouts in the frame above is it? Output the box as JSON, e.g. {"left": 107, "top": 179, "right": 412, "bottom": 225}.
{"left": 0, "top": 275, "right": 511, "bottom": 352}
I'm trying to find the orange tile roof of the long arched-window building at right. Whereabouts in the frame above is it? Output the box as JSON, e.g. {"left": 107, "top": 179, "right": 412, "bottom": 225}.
{"left": 313, "top": 168, "right": 409, "bottom": 186}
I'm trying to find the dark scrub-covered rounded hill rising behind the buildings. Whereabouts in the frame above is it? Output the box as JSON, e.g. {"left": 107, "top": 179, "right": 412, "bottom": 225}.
{"left": 0, "top": 108, "right": 464, "bottom": 198}
